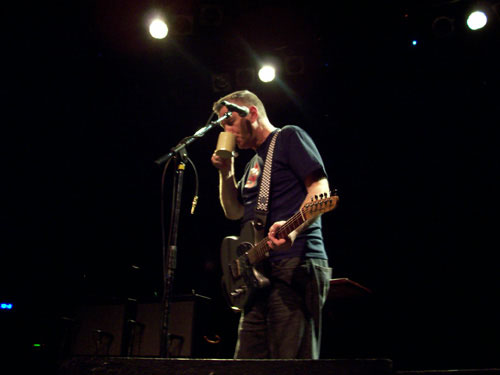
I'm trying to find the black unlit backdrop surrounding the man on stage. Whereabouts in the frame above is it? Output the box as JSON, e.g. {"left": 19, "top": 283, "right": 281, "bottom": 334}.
{"left": 0, "top": 0, "right": 500, "bottom": 369}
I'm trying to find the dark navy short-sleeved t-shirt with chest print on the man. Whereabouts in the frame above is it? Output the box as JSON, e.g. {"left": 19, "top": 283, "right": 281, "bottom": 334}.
{"left": 238, "top": 125, "right": 327, "bottom": 261}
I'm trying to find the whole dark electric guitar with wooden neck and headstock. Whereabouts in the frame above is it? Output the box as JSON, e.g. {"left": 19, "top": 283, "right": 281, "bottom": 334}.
{"left": 221, "top": 194, "right": 339, "bottom": 311}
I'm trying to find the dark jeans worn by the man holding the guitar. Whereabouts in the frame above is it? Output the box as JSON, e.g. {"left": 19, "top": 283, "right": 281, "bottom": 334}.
{"left": 234, "top": 258, "right": 332, "bottom": 359}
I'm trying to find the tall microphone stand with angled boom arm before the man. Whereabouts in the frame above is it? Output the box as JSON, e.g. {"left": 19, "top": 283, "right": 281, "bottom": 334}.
{"left": 155, "top": 111, "right": 232, "bottom": 358}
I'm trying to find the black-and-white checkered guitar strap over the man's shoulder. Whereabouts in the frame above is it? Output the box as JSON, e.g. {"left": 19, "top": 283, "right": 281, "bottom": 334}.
{"left": 253, "top": 129, "right": 281, "bottom": 243}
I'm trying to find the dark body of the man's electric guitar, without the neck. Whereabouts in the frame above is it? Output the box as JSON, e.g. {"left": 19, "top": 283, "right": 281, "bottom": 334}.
{"left": 221, "top": 223, "right": 270, "bottom": 310}
